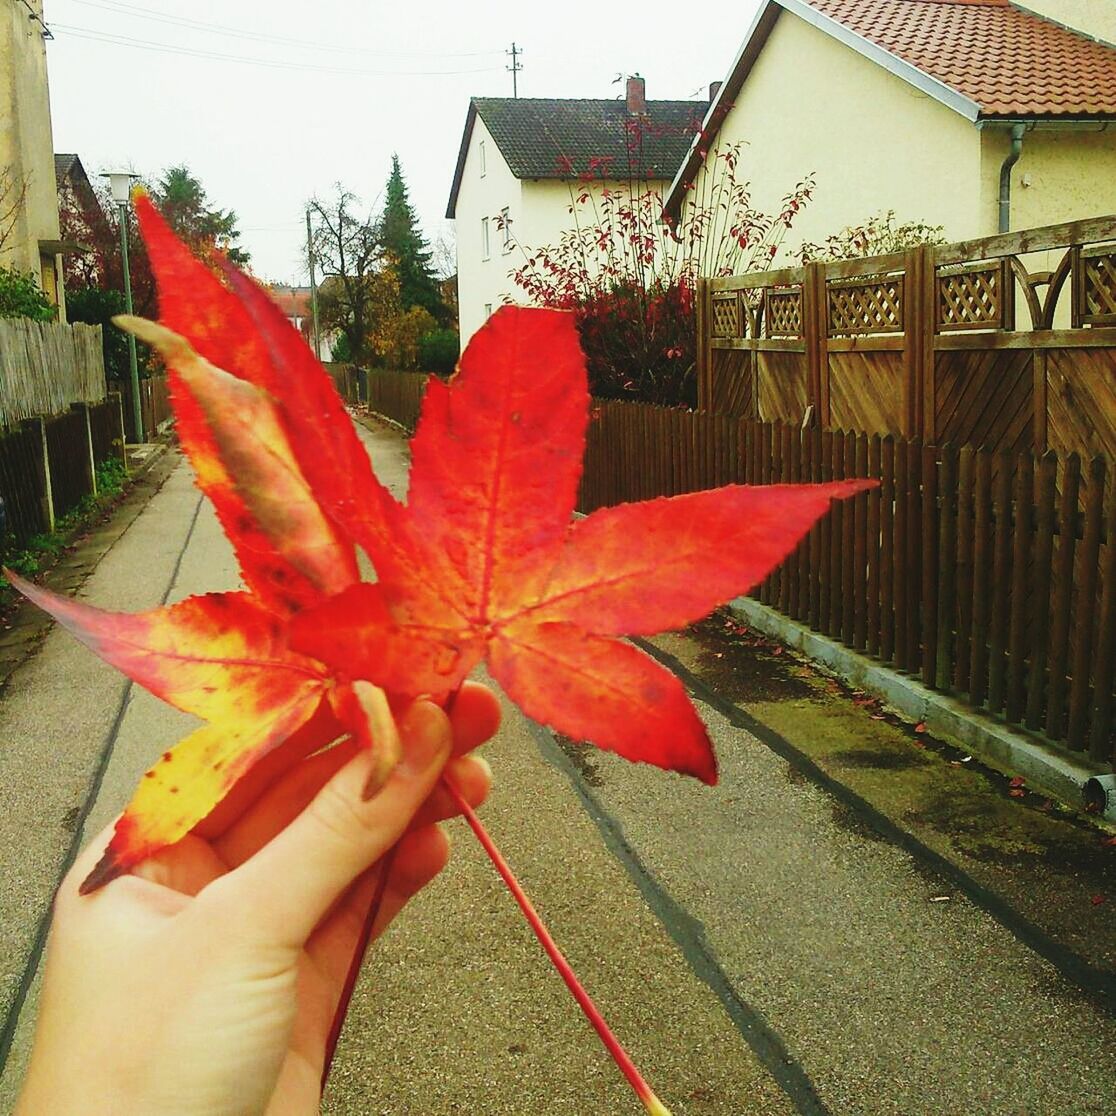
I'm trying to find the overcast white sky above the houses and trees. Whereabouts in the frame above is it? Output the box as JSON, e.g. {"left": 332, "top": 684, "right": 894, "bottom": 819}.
{"left": 46, "top": 0, "right": 758, "bottom": 281}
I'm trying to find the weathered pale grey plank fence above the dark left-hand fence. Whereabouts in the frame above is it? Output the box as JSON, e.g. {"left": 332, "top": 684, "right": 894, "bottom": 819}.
{"left": 0, "top": 318, "right": 106, "bottom": 426}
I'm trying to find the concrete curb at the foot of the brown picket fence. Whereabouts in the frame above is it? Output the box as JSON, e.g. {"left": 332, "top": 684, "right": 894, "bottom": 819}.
{"left": 729, "top": 597, "right": 1116, "bottom": 821}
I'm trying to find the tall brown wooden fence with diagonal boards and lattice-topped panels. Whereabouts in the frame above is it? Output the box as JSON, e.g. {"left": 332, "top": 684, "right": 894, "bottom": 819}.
{"left": 698, "top": 217, "right": 1116, "bottom": 460}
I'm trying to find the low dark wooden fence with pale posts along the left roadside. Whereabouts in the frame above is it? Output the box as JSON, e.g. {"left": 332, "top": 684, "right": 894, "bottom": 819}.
{"left": 0, "top": 394, "right": 124, "bottom": 543}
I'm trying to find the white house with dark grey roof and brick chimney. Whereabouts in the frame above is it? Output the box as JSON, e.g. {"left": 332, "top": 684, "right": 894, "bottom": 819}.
{"left": 445, "top": 75, "right": 708, "bottom": 345}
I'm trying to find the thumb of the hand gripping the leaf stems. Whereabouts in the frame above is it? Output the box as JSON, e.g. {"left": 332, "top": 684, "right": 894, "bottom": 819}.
{"left": 203, "top": 701, "right": 452, "bottom": 947}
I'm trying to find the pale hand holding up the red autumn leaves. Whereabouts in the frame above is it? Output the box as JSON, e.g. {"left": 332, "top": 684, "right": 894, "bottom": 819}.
{"left": 16, "top": 683, "right": 500, "bottom": 1116}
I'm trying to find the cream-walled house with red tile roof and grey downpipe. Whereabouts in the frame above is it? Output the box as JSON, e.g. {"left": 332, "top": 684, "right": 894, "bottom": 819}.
{"left": 665, "top": 0, "right": 1116, "bottom": 255}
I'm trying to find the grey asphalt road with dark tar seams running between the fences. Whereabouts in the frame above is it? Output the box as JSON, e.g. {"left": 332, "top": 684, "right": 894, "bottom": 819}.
{"left": 0, "top": 419, "right": 1116, "bottom": 1116}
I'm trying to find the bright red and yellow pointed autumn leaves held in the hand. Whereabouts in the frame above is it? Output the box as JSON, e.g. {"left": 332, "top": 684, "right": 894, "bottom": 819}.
{"left": 12, "top": 198, "right": 870, "bottom": 1110}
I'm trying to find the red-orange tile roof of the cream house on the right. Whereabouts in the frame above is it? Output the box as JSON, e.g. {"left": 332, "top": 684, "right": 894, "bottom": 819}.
{"left": 805, "top": 0, "right": 1116, "bottom": 117}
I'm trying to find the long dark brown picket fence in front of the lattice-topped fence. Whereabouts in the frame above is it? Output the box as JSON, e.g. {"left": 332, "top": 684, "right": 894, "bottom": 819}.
{"left": 579, "top": 401, "right": 1116, "bottom": 760}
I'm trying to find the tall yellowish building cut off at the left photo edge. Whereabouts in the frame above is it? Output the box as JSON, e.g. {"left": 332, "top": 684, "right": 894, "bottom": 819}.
{"left": 0, "top": 0, "right": 65, "bottom": 318}
